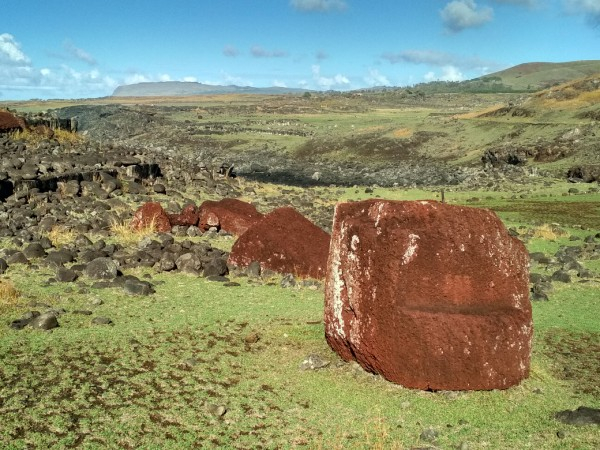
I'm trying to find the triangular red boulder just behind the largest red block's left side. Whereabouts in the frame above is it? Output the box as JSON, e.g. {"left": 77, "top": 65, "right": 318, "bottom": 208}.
{"left": 229, "top": 207, "right": 329, "bottom": 279}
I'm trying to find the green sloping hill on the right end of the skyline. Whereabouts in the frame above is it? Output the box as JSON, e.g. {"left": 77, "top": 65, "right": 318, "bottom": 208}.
{"left": 471, "top": 60, "right": 600, "bottom": 91}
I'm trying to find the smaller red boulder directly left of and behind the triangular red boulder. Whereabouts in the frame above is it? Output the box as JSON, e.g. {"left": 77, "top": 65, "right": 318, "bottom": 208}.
{"left": 198, "top": 198, "right": 263, "bottom": 236}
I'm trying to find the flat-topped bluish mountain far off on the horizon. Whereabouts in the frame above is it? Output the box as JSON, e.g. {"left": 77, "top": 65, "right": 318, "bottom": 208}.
{"left": 112, "top": 81, "right": 309, "bottom": 97}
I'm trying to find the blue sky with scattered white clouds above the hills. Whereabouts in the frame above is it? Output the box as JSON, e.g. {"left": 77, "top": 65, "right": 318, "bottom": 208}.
{"left": 0, "top": 0, "right": 600, "bottom": 100}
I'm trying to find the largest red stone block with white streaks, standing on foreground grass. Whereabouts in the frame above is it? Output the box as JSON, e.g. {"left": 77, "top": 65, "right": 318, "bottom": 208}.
{"left": 325, "top": 200, "right": 533, "bottom": 390}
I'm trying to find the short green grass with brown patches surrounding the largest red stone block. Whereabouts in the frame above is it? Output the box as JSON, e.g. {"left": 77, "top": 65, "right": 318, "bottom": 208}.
{"left": 0, "top": 183, "right": 600, "bottom": 449}
